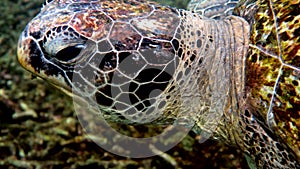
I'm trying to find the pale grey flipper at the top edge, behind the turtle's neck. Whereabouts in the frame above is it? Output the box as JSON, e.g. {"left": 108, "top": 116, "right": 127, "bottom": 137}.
{"left": 188, "top": 0, "right": 239, "bottom": 19}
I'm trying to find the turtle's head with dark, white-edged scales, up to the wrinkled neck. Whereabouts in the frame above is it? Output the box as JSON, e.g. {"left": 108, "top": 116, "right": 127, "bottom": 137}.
{"left": 18, "top": 0, "right": 185, "bottom": 124}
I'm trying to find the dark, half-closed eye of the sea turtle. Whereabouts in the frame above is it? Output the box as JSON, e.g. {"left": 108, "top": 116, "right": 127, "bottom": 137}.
{"left": 53, "top": 45, "right": 85, "bottom": 62}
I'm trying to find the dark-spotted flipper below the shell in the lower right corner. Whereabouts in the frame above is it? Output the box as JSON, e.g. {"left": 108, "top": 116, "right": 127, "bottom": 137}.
{"left": 237, "top": 109, "right": 300, "bottom": 168}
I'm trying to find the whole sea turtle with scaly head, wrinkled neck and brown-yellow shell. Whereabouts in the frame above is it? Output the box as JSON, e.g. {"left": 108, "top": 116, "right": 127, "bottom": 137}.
{"left": 18, "top": 0, "right": 300, "bottom": 168}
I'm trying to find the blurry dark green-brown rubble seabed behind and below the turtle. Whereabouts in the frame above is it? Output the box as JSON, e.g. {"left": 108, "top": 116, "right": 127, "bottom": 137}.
{"left": 0, "top": 0, "right": 248, "bottom": 169}
